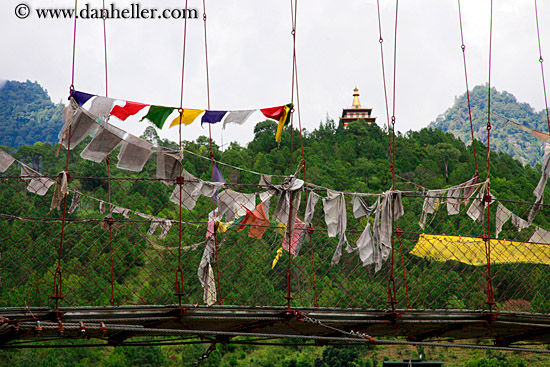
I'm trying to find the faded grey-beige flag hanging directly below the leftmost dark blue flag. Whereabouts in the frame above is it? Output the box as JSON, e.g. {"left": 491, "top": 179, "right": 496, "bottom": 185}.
{"left": 59, "top": 99, "right": 100, "bottom": 149}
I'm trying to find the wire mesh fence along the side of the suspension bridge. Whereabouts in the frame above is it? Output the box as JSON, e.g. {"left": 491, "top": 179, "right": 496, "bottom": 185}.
{"left": 0, "top": 168, "right": 550, "bottom": 313}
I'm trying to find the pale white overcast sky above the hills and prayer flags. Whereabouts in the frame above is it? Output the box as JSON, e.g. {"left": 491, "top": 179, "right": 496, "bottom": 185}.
{"left": 0, "top": 0, "right": 550, "bottom": 150}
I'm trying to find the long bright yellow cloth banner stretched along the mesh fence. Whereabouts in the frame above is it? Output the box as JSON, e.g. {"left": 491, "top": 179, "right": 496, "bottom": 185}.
{"left": 411, "top": 234, "right": 550, "bottom": 265}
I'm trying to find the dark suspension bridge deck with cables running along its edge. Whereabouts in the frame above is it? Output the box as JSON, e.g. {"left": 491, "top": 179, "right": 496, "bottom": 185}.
{"left": 0, "top": 305, "right": 550, "bottom": 347}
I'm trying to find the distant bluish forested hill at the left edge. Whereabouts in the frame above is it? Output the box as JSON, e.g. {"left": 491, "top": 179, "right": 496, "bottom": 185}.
{"left": 0, "top": 81, "right": 64, "bottom": 148}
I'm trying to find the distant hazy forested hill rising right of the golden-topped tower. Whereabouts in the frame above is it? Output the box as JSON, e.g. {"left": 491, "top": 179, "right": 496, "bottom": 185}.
{"left": 430, "top": 86, "right": 548, "bottom": 166}
